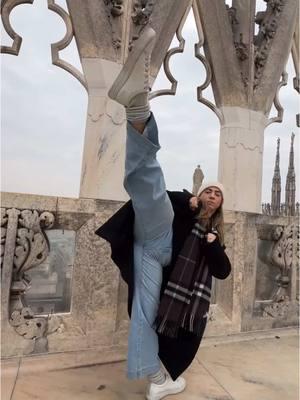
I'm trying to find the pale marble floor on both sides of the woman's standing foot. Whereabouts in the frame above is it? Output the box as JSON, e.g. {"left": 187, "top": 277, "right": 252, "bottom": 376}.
{"left": 1, "top": 331, "right": 299, "bottom": 400}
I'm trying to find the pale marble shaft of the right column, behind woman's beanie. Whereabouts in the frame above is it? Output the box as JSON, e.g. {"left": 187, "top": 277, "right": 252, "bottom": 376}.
{"left": 218, "top": 107, "right": 267, "bottom": 213}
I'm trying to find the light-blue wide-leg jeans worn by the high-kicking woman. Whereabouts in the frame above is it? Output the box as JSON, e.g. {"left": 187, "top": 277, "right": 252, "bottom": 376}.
{"left": 124, "top": 115, "right": 174, "bottom": 379}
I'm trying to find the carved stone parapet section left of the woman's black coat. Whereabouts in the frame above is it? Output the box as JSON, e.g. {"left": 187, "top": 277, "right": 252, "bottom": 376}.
{"left": 1, "top": 193, "right": 127, "bottom": 361}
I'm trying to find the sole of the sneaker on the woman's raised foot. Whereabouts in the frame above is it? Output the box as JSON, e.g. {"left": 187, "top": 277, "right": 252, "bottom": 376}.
{"left": 108, "top": 28, "right": 156, "bottom": 100}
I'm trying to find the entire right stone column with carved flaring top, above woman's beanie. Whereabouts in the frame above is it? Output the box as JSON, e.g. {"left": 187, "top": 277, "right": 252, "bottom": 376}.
{"left": 194, "top": 0, "right": 299, "bottom": 213}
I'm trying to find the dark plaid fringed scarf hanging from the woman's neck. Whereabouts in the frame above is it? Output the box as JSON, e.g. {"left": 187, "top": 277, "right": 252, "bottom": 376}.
{"left": 155, "top": 222, "right": 211, "bottom": 337}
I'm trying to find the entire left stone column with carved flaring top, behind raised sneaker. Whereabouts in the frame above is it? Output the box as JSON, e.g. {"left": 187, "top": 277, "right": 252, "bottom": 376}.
{"left": 65, "top": 0, "right": 192, "bottom": 200}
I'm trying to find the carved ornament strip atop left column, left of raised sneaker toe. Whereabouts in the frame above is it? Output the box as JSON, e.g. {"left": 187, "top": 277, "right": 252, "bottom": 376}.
{"left": 103, "top": 0, "right": 124, "bottom": 49}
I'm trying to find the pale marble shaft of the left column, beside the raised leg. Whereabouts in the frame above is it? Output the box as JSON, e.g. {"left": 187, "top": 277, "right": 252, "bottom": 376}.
{"left": 80, "top": 58, "right": 128, "bottom": 200}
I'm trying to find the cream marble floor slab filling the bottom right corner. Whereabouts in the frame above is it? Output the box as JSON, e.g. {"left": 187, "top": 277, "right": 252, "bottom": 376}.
{"left": 197, "top": 336, "right": 299, "bottom": 400}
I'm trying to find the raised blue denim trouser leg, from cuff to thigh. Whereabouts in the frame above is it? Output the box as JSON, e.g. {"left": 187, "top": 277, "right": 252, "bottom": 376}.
{"left": 124, "top": 115, "right": 174, "bottom": 242}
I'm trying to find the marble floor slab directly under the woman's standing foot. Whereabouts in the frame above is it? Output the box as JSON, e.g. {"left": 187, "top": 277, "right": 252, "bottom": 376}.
{"left": 12, "top": 360, "right": 232, "bottom": 400}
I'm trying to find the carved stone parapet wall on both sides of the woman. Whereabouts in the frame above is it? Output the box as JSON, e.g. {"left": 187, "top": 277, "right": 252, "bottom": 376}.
{"left": 1, "top": 193, "right": 299, "bottom": 365}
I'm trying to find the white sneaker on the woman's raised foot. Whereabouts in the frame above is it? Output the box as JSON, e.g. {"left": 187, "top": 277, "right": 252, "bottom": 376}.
{"left": 108, "top": 27, "right": 156, "bottom": 107}
